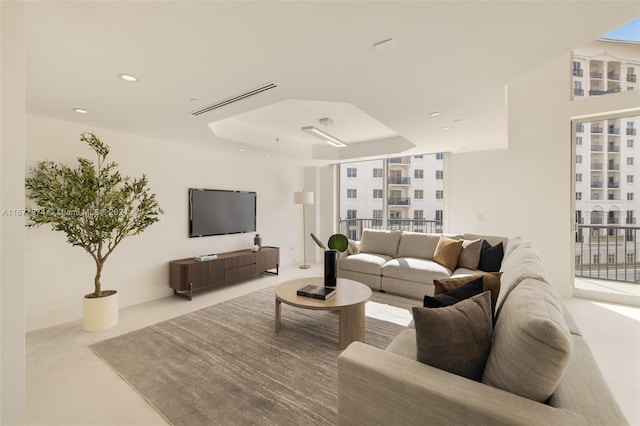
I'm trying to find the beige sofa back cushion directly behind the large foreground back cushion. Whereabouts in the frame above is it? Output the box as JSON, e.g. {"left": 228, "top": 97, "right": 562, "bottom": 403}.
{"left": 496, "top": 242, "right": 551, "bottom": 316}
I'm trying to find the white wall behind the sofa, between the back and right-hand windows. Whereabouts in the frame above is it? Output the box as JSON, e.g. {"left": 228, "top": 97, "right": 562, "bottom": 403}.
{"left": 448, "top": 55, "right": 640, "bottom": 297}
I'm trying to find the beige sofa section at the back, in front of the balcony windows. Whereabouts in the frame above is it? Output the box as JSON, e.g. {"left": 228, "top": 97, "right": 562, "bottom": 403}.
{"left": 338, "top": 229, "right": 513, "bottom": 299}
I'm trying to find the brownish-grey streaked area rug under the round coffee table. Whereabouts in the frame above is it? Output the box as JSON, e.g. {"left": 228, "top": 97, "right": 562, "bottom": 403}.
{"left": 90, "top": 288, "right": 404, "bottom": 425}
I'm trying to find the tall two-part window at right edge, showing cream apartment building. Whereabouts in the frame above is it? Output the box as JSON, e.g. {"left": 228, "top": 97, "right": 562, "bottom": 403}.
{"left": 571, "top": 24, "right": 640, "bottom": 298}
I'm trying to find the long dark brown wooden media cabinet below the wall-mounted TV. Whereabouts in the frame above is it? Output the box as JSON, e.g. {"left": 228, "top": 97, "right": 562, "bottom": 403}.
{"left": 169, "top": 247, "right": 280, "bottom": 300}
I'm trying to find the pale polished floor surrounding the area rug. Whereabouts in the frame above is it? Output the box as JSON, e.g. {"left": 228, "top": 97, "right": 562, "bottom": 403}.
{"left": 26, "top": 265, "right": 640, "bottom": 425}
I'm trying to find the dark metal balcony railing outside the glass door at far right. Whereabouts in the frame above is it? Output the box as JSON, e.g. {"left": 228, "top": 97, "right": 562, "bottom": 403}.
{"left": 575, "top": 225, "right": 640, "bottom": 283}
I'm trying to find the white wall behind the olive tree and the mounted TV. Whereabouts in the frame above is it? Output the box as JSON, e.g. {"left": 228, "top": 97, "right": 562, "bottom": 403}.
{"left": 25, "top": 116, "right": 303, "bottom": 330}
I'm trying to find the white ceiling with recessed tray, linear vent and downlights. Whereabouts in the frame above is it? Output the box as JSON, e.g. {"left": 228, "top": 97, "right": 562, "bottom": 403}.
{"left": 26, "top": 0, "right": 640, "bottom": 163}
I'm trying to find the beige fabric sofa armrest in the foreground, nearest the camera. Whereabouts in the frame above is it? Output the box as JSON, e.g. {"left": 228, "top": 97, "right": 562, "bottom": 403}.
{"left": 338, "top": 342, "right": 584, "bottom": 426}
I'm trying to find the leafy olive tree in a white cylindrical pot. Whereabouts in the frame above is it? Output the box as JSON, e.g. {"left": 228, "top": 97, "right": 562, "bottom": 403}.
{"left": 25, "top": 133, "right": 164, "bottom": 331}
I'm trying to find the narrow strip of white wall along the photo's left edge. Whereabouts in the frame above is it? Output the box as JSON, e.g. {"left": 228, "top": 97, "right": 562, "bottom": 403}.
{"left": 0, "top": 2, "right": 25, "bottom": 425}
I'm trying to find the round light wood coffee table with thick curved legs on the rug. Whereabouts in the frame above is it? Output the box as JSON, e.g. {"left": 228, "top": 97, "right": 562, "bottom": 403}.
{"left": 275, "top": 277, "right": 372, "bottom": 349}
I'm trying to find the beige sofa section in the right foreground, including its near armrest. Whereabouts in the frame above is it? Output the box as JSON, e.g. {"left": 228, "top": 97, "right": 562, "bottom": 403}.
{"left": 338, "top": 233, "right": 628, "bottom": 426}
